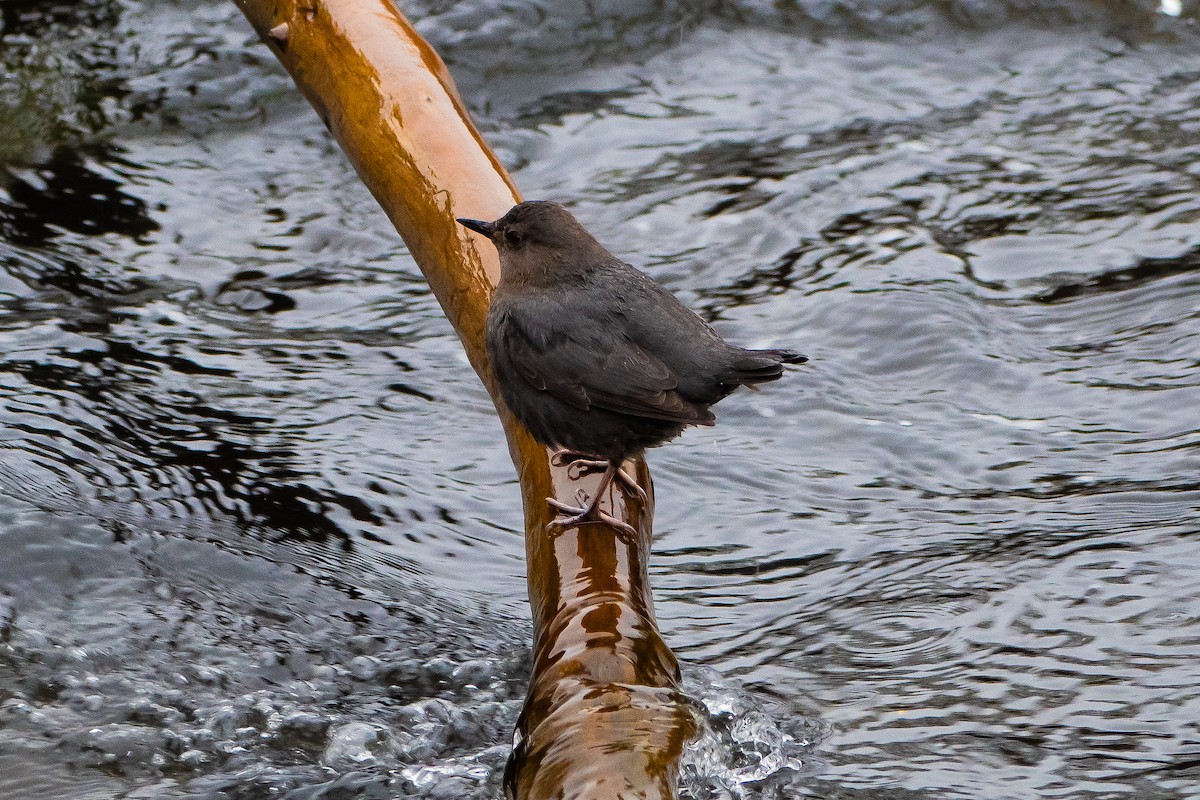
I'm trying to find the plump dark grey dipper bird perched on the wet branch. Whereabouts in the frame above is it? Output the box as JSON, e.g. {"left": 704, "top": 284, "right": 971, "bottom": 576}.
{"left": 458, "top": 200, "right": 808, "bottom": 535}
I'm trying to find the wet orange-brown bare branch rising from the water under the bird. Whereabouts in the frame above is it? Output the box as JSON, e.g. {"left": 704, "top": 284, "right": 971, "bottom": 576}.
{"left": 235, "top": 0, "right": 696, "bottom": 800}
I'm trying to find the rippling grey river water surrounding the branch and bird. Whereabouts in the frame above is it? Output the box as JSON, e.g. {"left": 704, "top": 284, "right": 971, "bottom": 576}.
{"left": 0, "top": 0, "right": 1200, "bottom": 800}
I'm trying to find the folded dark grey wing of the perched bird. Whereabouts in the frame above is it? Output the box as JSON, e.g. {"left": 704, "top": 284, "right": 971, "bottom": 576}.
{"left": 496, "top": 307, "right": 714, "bottom": 425}
